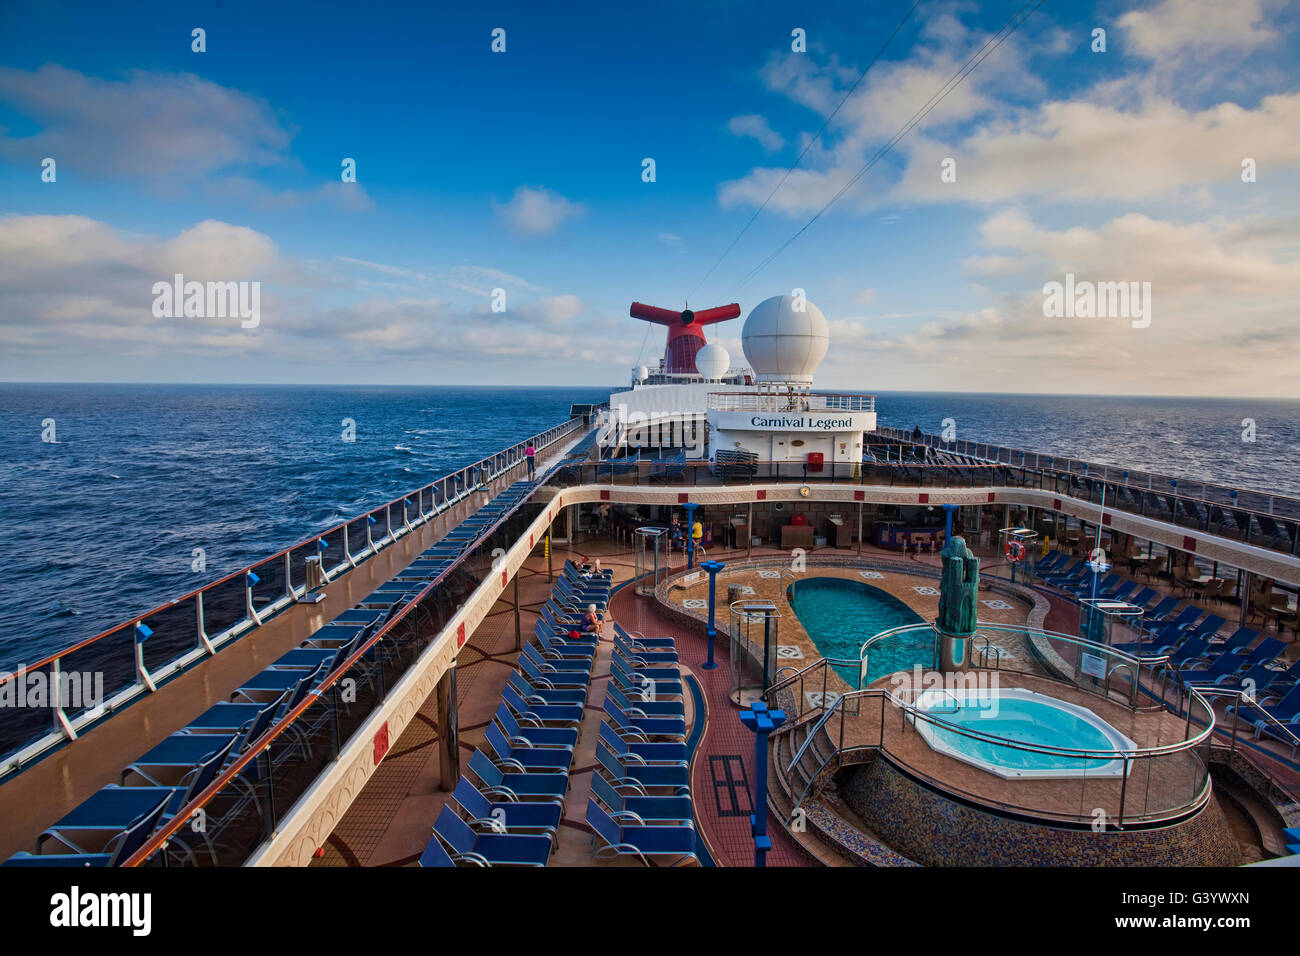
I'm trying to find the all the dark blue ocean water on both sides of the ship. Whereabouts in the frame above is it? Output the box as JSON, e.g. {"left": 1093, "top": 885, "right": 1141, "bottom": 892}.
{"left": 0, "top": 385, "right": 1300, "bottom": 669}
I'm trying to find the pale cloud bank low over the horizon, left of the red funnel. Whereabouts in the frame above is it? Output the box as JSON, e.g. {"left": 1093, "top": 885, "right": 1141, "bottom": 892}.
{"left": 0, "top": 216, "right": 636, "bottom": 384}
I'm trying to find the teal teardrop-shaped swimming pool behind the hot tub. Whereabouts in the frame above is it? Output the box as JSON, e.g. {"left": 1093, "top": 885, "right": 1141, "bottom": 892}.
{"left": 790, "top": 578, "right": 935, "bottom": 687}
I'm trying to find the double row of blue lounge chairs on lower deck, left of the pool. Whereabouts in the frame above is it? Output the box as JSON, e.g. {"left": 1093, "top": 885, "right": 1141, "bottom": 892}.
{"left": 420, "top": 562, "right": 697, "bottom": 866}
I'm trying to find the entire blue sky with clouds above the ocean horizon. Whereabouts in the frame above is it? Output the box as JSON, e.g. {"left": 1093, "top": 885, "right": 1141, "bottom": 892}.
{"left": 0, "top": 0, "right": 1300, "bottom": 395}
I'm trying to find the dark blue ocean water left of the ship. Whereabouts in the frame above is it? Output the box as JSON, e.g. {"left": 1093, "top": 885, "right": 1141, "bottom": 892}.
{"left": 0, "top": 384, "right": 608, "bottom": 670}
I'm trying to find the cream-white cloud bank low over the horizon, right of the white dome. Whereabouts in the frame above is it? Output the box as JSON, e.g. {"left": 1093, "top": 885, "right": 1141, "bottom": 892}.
{"left": 824, "top": 209, "right": 1300, "bottom": 397}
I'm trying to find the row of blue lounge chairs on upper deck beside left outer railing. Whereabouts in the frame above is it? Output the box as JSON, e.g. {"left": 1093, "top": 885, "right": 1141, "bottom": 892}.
{"left": 3, "top": 481, "right": 536, "bottom": 866}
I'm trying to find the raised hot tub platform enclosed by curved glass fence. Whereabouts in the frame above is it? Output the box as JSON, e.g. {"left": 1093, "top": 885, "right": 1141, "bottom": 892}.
{"left": 768, "top": 624, "right": 1214, "bottom": 830}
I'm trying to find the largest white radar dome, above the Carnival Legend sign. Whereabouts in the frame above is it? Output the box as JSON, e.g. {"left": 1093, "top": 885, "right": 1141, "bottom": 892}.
{"left": 741, "top": 295, "right": 831, "bottom": 385}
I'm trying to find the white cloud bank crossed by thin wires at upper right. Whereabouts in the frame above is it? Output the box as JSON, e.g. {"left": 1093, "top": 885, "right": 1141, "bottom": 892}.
{"left": 718, "top": 7, "right": 1300, "bottom": 217}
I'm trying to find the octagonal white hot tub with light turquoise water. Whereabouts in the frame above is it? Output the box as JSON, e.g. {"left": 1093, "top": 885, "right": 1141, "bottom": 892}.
{"left": 915, "top": 687, "right": 1138, "bottom": 779}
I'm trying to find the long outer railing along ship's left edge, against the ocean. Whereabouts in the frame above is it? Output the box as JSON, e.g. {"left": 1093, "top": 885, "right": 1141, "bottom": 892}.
{"left": 0, "top": 419, "right": 582, "bottom": 780}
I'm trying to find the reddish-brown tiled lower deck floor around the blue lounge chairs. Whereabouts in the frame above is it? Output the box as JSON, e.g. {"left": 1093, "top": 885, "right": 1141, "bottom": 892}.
{"left": 313, "top": 538, "right": 1300, "bottom": 866}
